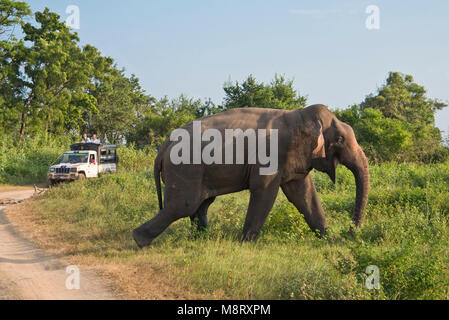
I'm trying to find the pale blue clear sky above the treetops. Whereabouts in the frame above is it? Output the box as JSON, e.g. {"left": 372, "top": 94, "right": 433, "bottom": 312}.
{"left": 30, "top": 0, "right": 449, "bottom": 131}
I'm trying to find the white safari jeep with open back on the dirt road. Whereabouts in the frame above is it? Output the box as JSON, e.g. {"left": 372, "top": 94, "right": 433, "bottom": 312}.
{"left": 47, "top": 143, "right": 118, "bottom": 185}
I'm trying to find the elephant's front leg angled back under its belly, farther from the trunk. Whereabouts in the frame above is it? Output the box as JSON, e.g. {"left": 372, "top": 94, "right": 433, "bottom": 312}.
{"left": 242, "top": 181, "right": 279, "bottom": 241}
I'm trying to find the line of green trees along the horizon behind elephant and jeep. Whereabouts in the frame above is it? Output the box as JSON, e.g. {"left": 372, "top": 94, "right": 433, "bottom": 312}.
{"left": 0, "top": 0, "right": 448, "bottom": 162}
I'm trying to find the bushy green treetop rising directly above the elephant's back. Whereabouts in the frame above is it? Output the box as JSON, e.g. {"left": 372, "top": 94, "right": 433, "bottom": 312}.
{"left": 221, "top": 75, "right": 307, "bottom": 110}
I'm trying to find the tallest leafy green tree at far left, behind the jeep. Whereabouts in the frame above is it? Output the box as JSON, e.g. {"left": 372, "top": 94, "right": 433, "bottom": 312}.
{"left": 0, "top": 8, "right": 113, "bottom": 140}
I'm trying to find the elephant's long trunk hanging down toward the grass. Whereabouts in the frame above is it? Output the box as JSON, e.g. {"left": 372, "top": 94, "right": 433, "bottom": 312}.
{"left": 343, "top": 147, "right": 370, "bottom": 226}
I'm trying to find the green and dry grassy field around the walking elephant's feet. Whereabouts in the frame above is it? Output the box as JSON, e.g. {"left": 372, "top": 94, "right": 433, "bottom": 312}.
{"left": 3, "top": 148, "right": 449, "bottom": 299}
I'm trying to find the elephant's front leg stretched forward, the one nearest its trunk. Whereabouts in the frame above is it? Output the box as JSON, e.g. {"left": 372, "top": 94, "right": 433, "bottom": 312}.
{"left": 281, "top": 174, "right": 327, "bottom": 237}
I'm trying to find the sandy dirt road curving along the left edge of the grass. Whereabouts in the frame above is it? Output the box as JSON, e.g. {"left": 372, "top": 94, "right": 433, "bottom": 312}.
{"left": 0, "top": 188, "right": 116, "bottom": 300}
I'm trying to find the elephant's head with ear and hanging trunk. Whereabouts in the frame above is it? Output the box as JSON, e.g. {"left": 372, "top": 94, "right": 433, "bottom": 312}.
{"left": 300, "top": 105, "right": 370, "bottom": 226}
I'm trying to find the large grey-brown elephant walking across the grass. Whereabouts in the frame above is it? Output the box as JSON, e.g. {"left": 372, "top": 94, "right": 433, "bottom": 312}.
{"left": 133, "top": 104, "right": 370, "bottom": 248}
